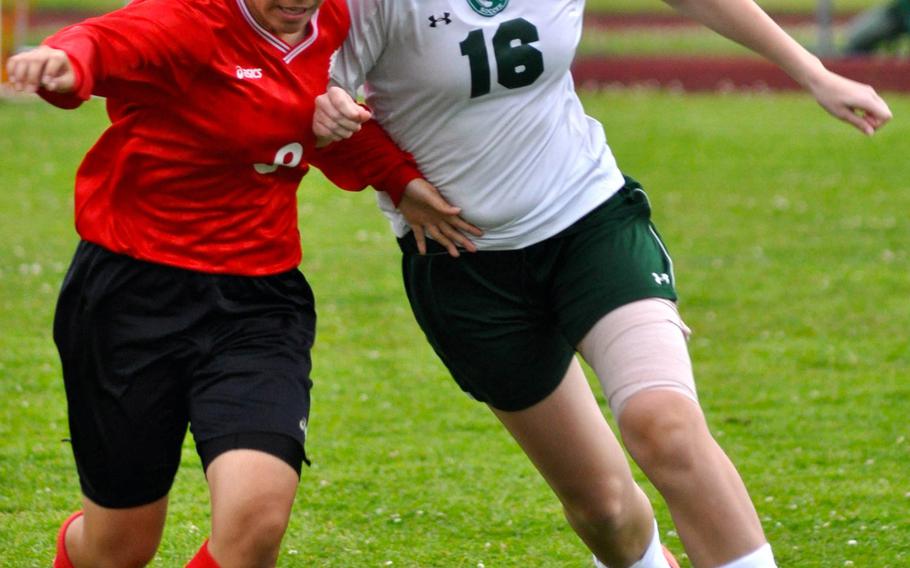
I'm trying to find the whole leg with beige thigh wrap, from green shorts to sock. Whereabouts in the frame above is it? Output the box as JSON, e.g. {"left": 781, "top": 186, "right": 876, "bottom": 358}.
{"left": 579, "top": 299, "right": 766, "bottom": 568}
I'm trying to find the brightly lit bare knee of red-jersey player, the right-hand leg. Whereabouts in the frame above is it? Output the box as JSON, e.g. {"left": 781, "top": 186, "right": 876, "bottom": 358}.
{"left": 206, "top": 450, "right": 298, "bottom": 568}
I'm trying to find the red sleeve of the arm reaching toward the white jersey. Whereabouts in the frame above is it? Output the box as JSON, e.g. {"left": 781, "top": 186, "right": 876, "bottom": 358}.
{"left": 309, "top": 120, "right": 423, "bottom": 207}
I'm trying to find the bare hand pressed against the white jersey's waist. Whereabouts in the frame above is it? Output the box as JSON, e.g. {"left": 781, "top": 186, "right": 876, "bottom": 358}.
{"left": 398, "top": 178, "right": 483, "bottom": 257}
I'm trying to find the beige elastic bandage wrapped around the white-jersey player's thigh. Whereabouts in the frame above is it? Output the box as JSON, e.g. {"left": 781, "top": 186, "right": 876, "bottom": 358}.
{"left": 578, "top": 298, "right": 698, "bottom": 418}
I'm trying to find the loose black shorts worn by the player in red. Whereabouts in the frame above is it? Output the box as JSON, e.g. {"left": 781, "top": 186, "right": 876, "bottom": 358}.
{"left": 54, "top": 242, "right": 316, "bottom": 508}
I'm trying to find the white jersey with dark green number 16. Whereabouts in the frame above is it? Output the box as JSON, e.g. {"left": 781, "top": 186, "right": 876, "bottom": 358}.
{"left": 332, "top": 0, "right": 623, "bottom": 250}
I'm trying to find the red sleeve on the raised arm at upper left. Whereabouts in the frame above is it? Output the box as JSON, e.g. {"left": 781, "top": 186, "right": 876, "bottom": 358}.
{"left": 39, "top": 0, "right": 214, "bottom": 108}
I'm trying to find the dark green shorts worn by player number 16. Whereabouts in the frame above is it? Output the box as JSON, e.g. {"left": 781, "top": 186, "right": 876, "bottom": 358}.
{"left": 399, "top": 178, "right": 676, "bottom": 411}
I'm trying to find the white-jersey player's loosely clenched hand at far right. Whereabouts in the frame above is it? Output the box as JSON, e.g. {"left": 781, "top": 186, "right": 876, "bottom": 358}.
{"left": 809, "top": 70, "right": 891, "bottom": 136}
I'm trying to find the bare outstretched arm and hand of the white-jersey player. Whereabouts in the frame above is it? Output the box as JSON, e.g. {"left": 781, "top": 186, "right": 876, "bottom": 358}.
{"left": 664, "top": 0, "right": 891, "bottom": 135}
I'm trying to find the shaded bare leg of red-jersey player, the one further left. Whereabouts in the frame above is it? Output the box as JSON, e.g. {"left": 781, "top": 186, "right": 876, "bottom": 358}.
{"left": 64, "top": 497, "right": 167, "bottom": 568}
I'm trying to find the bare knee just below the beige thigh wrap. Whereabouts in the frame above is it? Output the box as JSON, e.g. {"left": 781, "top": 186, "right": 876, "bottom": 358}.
{"left": 619, "top": 391, "right": 709, "bottom": 474}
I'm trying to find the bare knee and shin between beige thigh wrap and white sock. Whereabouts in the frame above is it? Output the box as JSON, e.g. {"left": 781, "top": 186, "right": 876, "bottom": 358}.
{"left": 619, "top": 389, "right": 767, "bottom": 567}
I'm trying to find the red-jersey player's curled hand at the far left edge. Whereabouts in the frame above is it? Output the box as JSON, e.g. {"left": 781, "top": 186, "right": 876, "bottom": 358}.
{"left": 6, "top": 45, "right": 76, "bottom": 93}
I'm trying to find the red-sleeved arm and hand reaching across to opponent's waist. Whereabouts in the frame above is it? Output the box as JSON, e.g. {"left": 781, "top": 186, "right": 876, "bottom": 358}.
{"left": 310, "top": 118, "right": 483, "bottom": 257}
